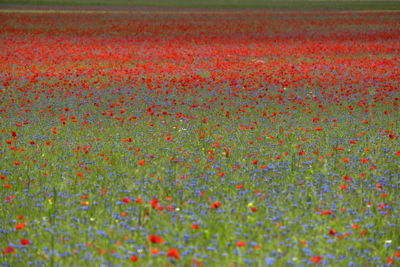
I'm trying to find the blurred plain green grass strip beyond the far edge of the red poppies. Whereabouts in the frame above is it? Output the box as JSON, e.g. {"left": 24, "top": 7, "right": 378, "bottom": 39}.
{"left": 0, "top": 0, "right": 400, "bottom": 10}
